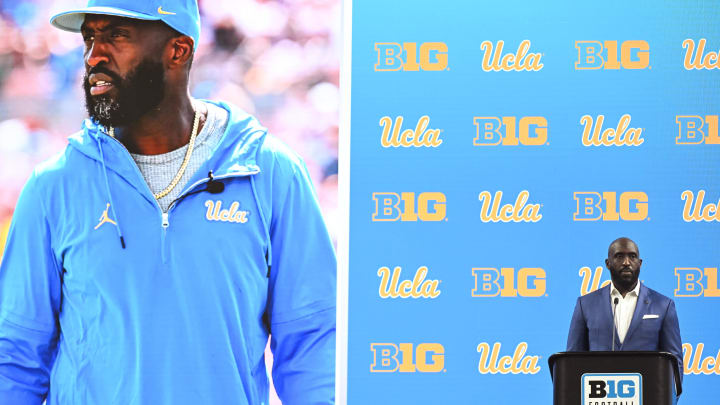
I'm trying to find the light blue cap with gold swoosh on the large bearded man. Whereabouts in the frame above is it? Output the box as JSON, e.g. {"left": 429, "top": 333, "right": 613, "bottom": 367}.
{"left": 50, "top": 0, "right": 200, "bottom": 48}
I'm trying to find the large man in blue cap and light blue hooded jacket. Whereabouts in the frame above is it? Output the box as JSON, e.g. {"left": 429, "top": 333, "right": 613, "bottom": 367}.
{"left": 0, "top": 0, "right": 335, "bottom": 405}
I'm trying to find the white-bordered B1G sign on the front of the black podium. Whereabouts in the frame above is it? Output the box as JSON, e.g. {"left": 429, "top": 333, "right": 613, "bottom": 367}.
{"left": 581, "top": 373, "right": 642, "bottom": 405}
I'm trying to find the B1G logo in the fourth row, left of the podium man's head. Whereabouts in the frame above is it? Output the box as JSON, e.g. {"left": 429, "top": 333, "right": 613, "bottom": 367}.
{"left": 472, "top": 267, "right": 546, "bottom": 297}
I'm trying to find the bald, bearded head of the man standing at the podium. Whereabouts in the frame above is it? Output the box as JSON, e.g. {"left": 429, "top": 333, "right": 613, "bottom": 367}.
{"left": 605, "top": 238, "right": 642, "bottom": 297}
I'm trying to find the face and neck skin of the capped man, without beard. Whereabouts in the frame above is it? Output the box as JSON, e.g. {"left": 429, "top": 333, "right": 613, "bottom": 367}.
{"left": 81, "top": 14, "right": 207, "bottom": 155}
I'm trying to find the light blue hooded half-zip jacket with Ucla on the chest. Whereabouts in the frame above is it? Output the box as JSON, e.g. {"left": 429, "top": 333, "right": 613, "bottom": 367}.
{"left": 0, "top": 103, "right": 336, "bottom": 405}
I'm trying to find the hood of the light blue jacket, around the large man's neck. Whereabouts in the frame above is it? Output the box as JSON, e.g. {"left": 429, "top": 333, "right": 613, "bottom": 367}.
{"left": 69, "top": 100, "right": 267, "bottom": 177}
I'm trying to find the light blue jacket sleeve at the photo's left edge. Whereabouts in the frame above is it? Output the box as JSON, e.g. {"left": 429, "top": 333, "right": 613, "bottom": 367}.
{"left": 0, "top": 172, "right": 61, "bottom": 405}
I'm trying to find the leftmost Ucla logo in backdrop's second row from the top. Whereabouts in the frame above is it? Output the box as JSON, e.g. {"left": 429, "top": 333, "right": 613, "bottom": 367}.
{"left": 380, "top": 115, "right": 442, "bottom": 148}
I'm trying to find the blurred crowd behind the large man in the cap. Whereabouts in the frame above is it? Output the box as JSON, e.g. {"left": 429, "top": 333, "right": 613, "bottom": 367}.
{"left": 0, "top": 0, "right": 341, "bottom": 259}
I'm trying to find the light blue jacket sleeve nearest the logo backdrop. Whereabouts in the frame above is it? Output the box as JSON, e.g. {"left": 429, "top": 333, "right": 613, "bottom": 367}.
{"left": 268, "top": 161, "right": 336, "bottom": 405}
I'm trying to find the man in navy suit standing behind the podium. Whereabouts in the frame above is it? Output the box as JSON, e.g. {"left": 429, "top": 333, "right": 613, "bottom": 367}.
{"left": 567, "top": 238, "right": 683, "bottom": 392}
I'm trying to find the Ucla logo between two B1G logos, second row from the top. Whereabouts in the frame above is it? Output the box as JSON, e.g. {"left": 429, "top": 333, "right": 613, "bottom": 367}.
{"left": 580, "top": 114, "right": 645, "bottom": 146}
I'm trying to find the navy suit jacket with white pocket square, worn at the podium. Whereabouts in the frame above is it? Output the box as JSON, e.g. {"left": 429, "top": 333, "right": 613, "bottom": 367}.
{"left": 567, "top": 283, "right": 684, "bottom": 382}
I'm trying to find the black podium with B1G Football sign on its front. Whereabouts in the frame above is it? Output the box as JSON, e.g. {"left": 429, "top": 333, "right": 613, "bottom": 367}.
{"left": 548, "top": 351, "right": 682, "bottom": 405}
